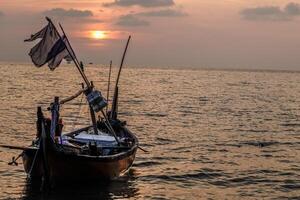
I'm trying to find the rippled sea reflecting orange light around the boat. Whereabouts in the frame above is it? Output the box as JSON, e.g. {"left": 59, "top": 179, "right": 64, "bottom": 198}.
{"left": 0, "top": 64, "right": 300, "bottom": 199}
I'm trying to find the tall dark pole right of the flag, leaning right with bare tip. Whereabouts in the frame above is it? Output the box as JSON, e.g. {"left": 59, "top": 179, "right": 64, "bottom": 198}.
{"left": 110, "top": 35, "right": 131, "bottom": 119}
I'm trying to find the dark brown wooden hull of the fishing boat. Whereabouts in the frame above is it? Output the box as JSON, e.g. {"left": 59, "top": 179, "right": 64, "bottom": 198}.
{"left": 23, "top": 125, "right": 138, "bottom": 180}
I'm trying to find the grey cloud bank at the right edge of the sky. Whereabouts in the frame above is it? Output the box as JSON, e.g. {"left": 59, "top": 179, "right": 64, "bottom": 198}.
{"left": 240, "top": 3, "right": 300, "bottom": 21}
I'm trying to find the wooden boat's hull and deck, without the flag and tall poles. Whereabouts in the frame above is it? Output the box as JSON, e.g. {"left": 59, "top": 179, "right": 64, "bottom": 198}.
{"left": 22, "top": 98, "right": 138, "bottom": 182}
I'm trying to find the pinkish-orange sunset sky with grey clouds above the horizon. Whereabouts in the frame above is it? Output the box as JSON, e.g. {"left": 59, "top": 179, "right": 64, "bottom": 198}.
{"left": 0, "top": 0, "right": 300, "bottom": 70}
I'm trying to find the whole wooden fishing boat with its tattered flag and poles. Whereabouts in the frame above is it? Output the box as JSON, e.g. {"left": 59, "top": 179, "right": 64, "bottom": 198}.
{"left": 1, "top": 18, "right": 139, "bottom": 183}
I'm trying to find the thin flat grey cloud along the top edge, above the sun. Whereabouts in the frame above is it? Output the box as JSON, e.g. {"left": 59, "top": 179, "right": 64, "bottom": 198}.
{"left": 103, "top": 0, "right": 175, "bottom": 7}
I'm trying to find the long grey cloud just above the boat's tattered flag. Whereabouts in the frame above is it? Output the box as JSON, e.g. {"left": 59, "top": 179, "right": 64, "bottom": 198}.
{"left": 43, "top": 8, "right": 93, "bottom": 17}
